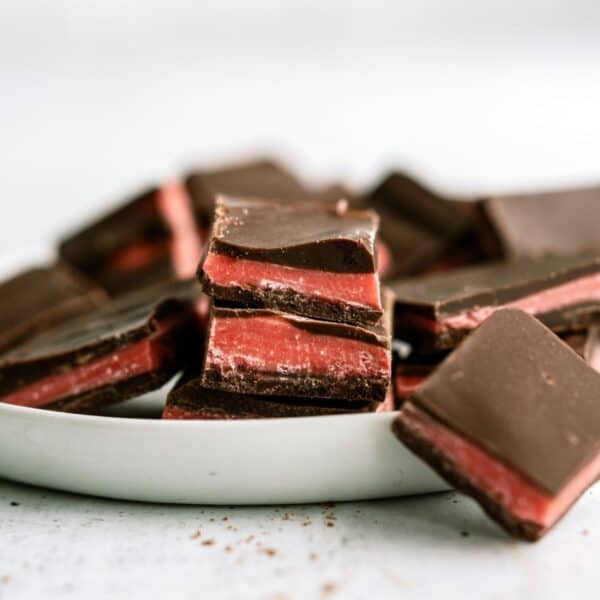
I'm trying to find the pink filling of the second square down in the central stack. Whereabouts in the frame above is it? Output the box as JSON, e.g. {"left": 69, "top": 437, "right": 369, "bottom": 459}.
{"left": 206, "top": 315, "right": 390, "bottom": 380}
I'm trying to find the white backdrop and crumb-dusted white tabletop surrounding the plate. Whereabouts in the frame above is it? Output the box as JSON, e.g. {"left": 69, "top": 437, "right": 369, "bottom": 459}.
{"left": 0, "top": 0, "right": 600, "bottom": 600}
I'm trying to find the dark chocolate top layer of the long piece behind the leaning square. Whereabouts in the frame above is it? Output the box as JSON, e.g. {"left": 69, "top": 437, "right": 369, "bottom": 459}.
{"left": 391, "top": 256, "right": 600, "bottom": 318}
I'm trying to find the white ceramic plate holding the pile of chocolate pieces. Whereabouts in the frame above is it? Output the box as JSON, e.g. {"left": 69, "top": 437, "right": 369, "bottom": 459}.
{"left": 0, "top": 391, "right": 448, "bottom": 504}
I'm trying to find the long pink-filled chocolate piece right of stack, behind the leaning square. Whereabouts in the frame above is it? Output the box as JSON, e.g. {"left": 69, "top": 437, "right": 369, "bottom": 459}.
{"left": 392, "top": 256, "right": 600, "bottom": 352}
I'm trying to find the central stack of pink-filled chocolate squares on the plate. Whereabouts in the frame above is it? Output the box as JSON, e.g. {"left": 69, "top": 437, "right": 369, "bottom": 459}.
{"left": 163, "top": 197, "right": 392, "bottom": 419}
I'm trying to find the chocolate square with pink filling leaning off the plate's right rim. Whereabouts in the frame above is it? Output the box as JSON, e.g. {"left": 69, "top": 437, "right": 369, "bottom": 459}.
{"left": 393, "top": 309, "right": 600, "bottom": 541}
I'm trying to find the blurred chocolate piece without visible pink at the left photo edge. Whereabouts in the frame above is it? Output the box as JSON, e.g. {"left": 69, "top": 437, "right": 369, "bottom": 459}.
{"left": 0, "top": 263, "right": 108, "bottom": 352}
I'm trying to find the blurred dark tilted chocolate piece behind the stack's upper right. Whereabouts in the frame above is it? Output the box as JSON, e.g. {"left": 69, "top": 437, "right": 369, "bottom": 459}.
{"left": 368, "top": 172, "right": 484, "bottom": 280}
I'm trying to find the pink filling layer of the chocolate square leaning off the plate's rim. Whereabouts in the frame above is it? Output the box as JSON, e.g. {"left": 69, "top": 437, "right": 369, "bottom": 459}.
{"left": 400, "top": 404, "right": 600, "bottom": 528}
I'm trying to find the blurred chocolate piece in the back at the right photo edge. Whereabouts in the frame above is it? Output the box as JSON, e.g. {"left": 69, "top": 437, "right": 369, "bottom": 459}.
{"left": 479, "top": 187, "right": 600, "bottom": 259}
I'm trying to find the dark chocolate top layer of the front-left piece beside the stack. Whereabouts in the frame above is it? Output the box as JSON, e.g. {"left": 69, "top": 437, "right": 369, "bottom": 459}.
{"left": 0, "top": 281, "right": 201, "bottom": 394}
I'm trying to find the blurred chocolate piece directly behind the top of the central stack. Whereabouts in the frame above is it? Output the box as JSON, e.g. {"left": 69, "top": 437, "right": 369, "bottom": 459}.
{"left": 185, "top": 160, "right": 310, "bottom": 227}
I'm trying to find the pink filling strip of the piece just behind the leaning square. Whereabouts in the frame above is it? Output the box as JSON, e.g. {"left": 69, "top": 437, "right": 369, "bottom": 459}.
{"left": 401, "top": 273, "right": 600, "bottom": 333}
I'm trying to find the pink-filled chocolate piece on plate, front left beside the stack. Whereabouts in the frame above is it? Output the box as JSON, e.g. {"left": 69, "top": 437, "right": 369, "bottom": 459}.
{"left": 0, "top": 282, "right": 203, "bottom": 412}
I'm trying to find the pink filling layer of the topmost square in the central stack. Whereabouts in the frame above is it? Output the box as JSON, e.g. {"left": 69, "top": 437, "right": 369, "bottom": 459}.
{"left": 204, "top": 252, "right": 382, "bottom": 311}
